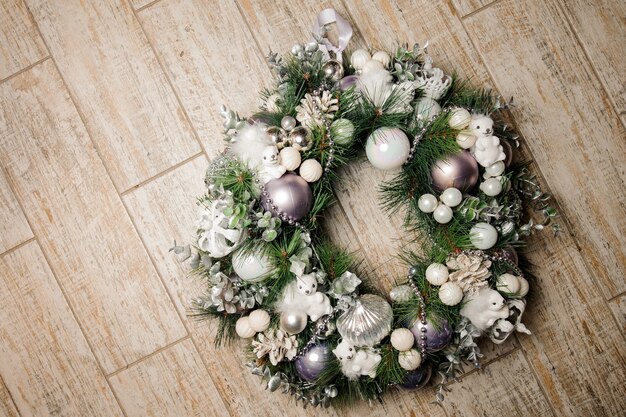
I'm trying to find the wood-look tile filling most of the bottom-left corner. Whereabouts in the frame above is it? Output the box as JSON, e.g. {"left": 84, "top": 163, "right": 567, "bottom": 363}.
{"left": 0, "top": 242, "right": 123, "bottom": 417}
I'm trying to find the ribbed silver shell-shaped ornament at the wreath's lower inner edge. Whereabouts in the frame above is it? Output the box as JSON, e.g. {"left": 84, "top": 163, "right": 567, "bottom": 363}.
{"left": 337, "top": 294, "right": 393, "bottom": 346}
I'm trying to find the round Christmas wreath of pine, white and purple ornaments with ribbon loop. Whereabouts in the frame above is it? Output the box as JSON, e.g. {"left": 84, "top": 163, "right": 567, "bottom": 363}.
{"left": 174, "top": 10, "right": 558, "bottom": 406}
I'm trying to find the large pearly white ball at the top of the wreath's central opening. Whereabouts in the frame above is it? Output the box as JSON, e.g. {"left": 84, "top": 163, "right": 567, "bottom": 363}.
{"left": 365, "top": 127, "right": 411, "bottom": 170}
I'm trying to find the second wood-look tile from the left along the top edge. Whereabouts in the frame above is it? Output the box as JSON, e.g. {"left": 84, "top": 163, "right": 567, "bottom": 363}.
{"left": 27, "top": 0, "right": 200, "bottom": 191}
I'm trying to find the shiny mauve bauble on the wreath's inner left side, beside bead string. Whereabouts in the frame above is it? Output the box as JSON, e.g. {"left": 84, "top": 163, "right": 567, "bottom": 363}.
{"left": 261, "top": 173, "right": 313, "bottom": 221}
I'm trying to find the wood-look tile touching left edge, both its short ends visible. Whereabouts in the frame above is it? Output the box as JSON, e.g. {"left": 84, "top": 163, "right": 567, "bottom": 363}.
{"left": 0, "top": 61, "right": 186, "bottom": 373}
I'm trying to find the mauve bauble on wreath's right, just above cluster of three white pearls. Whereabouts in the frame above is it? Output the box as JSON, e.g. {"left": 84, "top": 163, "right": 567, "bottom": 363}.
{"left": 430, "top": 151, "right": 479, "bottom": 191}
